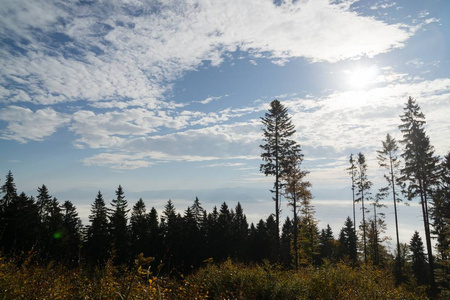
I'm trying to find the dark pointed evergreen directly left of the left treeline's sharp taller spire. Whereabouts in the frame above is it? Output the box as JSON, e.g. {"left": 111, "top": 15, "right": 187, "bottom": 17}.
{"left": 85, "top": 191, "right": 111, "bottom": 265}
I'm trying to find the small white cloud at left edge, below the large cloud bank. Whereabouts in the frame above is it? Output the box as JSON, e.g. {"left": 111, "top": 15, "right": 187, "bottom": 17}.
{"left": 0, "top": 105, "right": 70, "bottom": 143}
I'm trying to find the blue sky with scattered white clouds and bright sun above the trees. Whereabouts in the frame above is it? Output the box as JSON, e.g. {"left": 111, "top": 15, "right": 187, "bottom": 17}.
{"left": 0, "top": 0, "right": 450, "bottom": 248}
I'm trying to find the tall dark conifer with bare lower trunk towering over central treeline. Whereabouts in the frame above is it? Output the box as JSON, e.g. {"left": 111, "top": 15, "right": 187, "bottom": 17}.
{"left": 260, "top": 100, "right": 300, "bottom": 243}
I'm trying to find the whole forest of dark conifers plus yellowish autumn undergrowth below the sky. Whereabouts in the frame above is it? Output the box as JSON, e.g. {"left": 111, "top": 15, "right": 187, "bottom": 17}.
{"left": 0, "top": 97, "right": 450, "bottom": 299}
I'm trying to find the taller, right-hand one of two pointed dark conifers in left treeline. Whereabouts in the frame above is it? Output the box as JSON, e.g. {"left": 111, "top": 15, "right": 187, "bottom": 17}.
{"left": 109, "top": 185, "right": 129, "bottom": 264}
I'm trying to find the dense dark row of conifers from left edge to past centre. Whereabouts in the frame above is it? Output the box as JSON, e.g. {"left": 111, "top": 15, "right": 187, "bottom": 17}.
{"left": 0, "top": 176, "right": 340, "bottom": 273}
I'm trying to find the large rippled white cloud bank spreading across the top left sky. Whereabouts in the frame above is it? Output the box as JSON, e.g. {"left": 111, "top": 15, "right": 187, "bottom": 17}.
{"left": 0, "top": 0, "right": 412, "bottom": 108}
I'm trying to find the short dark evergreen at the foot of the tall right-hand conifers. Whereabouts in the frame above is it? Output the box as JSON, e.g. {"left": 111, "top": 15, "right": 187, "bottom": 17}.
{"left": 409, "top": 231, "right": 428, "bottom": 285}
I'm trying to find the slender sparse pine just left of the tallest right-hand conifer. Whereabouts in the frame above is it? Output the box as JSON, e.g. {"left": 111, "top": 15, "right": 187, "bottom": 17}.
{"left": 377, "top": 133, "right": 402, "bottom": 267}
